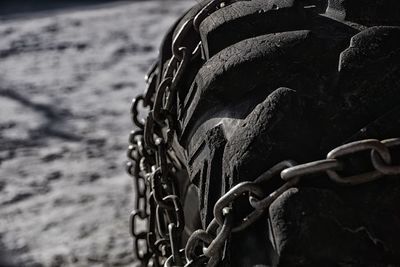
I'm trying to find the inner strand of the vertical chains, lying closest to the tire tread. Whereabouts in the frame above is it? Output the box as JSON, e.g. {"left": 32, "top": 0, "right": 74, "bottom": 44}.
{"left": 150, "top": 0, "right": 230, "bottom": 266}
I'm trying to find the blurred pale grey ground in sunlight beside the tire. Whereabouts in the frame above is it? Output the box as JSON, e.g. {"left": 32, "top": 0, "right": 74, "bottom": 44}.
{"left": 0, "top": 0, "right": 194, "bottom": 266}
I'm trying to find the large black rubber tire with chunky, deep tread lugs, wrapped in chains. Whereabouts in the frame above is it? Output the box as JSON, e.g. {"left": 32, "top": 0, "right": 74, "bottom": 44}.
{"left": 167, "top": 0, "right": 400, "bottom": 266}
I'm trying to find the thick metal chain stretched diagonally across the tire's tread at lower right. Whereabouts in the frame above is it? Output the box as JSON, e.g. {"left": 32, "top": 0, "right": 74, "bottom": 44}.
{"left": 185, "top": 138, "right": 400, "bottom": 266}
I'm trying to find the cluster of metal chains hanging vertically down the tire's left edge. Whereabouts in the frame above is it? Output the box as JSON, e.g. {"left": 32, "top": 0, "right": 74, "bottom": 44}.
{"left": 127, "top": 0, "right": 230, "bottom": 266}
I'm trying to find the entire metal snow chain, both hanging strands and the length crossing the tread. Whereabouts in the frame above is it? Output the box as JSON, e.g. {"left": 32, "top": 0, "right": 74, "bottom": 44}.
{"left": 127, "top": 0, "right": 400, "bottom": 267}
